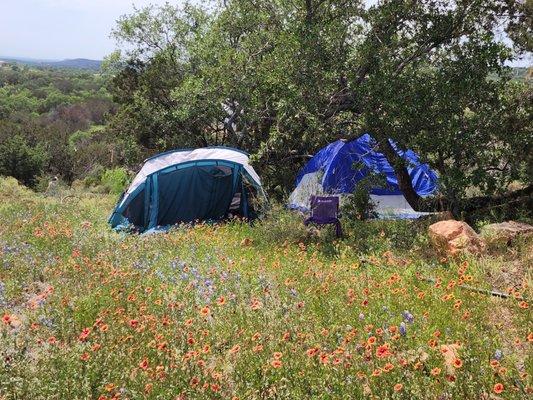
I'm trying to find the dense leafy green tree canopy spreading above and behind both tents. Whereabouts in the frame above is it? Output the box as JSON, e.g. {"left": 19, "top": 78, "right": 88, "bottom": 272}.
{"left": 107, "top": 0, "right": 533, "bottom": 216}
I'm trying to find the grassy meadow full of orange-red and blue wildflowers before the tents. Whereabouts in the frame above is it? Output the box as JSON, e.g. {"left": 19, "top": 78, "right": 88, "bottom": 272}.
{"left": 0, "top": 179, "right": 533, "bottom": 400}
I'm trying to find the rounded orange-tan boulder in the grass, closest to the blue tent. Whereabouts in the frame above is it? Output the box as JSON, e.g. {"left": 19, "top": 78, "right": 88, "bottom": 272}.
{"left": 429, "top": 220, "right": 486, "bottom": 256}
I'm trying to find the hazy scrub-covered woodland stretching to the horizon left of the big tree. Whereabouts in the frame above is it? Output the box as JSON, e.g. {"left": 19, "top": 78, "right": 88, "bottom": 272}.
{"left": 0, "top": 66, "right": 116, "bottom": 182}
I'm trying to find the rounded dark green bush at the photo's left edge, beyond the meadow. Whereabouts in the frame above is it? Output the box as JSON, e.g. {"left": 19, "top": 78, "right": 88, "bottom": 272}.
{"left": 0, "top": 135, "right": 47, "bottom": 186}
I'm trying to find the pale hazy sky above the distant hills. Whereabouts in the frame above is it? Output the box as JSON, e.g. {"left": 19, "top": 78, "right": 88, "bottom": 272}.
{"left": 0, "top": 0, "right": 532, "bottom": 66}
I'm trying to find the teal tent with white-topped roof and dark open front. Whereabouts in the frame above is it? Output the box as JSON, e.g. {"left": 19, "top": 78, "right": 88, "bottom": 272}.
{"left": 109, "top": 147, "right": 266, "bottom": 232}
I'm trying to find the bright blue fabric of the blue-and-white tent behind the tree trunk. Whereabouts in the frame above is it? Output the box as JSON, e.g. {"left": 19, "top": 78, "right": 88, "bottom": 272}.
{"left": 296, "top": 134, "right": 438, "bottom": 196}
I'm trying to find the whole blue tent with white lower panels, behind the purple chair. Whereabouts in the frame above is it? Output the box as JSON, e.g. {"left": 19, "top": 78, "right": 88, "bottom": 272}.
{"left": 289, "top": 134, "right": 438, "bottom": 218}
